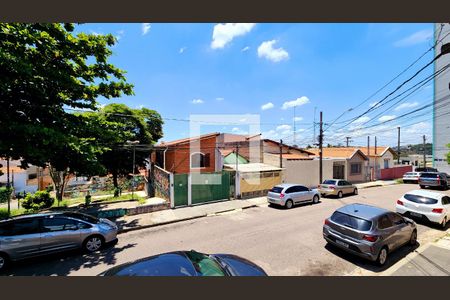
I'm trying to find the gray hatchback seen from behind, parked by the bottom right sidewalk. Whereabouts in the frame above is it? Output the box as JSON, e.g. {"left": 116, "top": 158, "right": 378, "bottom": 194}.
{"left": 323, "top": 204, "right": 417, "bottom": 265}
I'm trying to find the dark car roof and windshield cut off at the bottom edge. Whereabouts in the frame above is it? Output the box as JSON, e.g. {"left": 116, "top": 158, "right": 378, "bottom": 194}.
{"left": 99, "top": 250, "right": 267, "bottom": 276}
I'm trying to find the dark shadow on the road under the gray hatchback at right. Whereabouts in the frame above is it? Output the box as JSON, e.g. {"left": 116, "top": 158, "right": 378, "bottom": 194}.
{"left": 325, "top": 243, "right": 420, "bottom": 273}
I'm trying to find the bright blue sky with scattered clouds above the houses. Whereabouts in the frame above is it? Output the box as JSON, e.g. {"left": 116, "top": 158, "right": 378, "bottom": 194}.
{"left": 77, "top": 23, "right": 434, "bottom": 146}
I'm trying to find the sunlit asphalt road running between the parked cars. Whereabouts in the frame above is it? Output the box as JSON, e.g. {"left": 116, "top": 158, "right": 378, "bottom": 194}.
{"left": 5, "top": 185, "right": 450, "bottom": 276}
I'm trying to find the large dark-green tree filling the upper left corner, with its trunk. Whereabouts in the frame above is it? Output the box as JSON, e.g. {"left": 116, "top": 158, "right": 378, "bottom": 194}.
{"left": 0, "top": 23, "right": 133, "bottom": 201}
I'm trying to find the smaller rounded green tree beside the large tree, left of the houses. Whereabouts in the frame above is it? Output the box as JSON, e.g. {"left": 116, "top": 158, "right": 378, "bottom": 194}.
{"left": 83, "top": 103, "right": 163, "bottom": 188}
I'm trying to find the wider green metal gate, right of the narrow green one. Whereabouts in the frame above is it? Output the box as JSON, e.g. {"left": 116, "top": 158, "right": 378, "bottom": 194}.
{"left": 191, "top": 172, "right": 230, "bottom": 204}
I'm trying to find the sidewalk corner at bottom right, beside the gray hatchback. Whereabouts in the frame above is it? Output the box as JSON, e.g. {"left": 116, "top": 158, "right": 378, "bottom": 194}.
{"left": 381, "top": 233, "right": 450, "bottom": 276}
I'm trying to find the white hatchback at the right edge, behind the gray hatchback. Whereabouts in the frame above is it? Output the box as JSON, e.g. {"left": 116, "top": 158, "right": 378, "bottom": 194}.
{"left": 395, "top": 190, "right": 450, "bottom": 228}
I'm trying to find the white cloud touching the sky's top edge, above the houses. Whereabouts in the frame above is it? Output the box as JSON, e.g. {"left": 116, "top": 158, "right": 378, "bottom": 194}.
{"left": 211, "top": 23, "right": 255, "bottom": 49}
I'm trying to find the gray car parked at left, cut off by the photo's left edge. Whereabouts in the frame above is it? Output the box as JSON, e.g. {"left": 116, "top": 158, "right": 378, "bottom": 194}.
{"left": 0, "top": 212, "right": 118, "bottom": 270}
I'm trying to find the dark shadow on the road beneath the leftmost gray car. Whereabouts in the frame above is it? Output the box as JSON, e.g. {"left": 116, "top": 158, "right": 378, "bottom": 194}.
{"left": 0, "top": 242, "right": 136, "bottom": 276}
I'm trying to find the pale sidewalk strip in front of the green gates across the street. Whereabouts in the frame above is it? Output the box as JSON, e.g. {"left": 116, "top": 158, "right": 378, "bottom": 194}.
{"left": 116, "top": 197, "right": 267, "bottom": 233}
